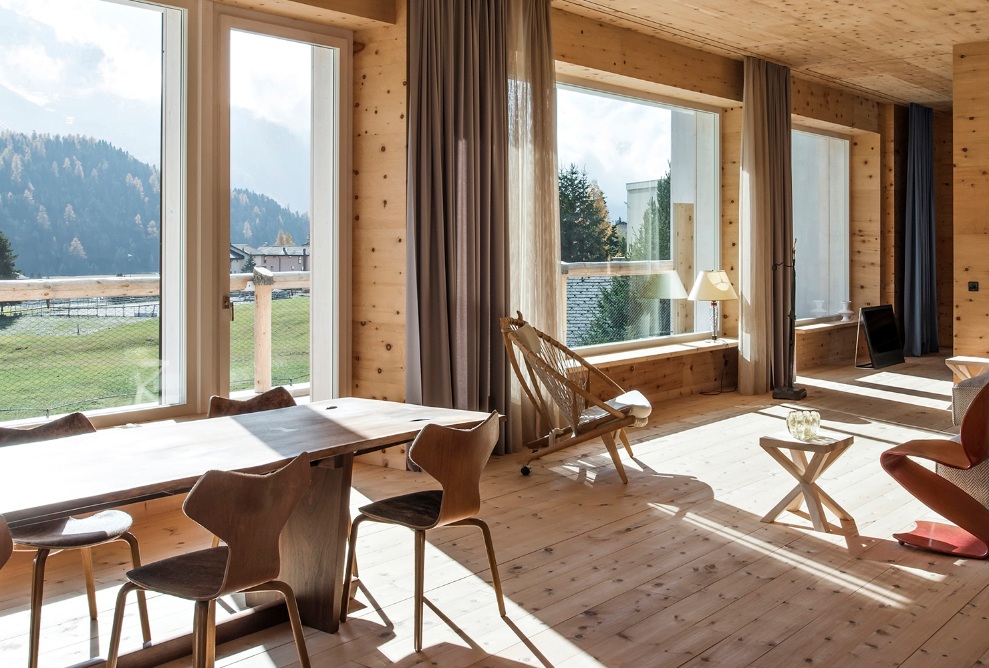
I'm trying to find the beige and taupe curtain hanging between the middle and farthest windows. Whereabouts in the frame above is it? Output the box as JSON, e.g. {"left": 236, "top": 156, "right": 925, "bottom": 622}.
{"left": 738, "top": 57, "right": 793, "bottom": 394}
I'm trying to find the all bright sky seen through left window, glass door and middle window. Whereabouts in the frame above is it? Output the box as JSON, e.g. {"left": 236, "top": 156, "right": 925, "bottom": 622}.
{"left": 0, "top": 0, "right": 670, "bottom": 220}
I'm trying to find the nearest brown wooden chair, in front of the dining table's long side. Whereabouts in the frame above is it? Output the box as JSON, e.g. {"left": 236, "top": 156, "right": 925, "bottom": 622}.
{"left": 106, "top": 453, "right": 311, "bottom": 668}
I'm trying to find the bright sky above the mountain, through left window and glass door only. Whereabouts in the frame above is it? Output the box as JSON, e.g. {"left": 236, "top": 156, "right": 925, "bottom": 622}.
{"left": 0, "top": 0, "right": 311, "bottom": 162}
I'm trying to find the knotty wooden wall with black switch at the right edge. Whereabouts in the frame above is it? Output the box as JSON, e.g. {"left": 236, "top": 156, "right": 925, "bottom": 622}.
{"left": 952, "top": 42, "right": 989, "bottom": 357}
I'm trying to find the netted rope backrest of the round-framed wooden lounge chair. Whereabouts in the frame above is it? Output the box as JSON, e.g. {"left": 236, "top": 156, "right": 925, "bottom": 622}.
{"left": 501, "top": 313, "right": 625, "bottom": 432}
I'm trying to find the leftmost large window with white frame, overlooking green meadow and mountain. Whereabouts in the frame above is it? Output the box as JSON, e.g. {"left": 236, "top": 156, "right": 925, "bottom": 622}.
{"left": 0, "top": 0, "right": 186, "bottom": 421}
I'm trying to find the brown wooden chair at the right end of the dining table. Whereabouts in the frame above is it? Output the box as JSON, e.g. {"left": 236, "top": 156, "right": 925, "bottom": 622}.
{"left": 340, "top": 413, "right": 505, "bottom": 652}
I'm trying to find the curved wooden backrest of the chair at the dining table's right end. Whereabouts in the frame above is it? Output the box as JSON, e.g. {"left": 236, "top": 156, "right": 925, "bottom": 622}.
{"left": 409, "top": 411, "right": 500, "bottom": 526}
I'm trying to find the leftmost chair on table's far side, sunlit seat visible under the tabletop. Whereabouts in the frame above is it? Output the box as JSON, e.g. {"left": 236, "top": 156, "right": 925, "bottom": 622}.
{"left": 0, "top": 413, "right": 151, "bottom": 668}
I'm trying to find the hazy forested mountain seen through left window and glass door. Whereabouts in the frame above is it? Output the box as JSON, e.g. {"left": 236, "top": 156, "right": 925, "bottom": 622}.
{"left": 0, "top": 131, "right": 309, "bottom": 277}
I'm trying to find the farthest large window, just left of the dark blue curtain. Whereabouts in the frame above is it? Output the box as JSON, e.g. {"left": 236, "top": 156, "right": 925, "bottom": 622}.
{"left": 791, "top": 130, "right": 849, "bottom": 319}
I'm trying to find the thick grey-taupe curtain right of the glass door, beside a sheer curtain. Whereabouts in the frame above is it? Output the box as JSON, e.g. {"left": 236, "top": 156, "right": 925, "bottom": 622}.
{"left": 406, "top": 0, "right": 510, "bottom": 444}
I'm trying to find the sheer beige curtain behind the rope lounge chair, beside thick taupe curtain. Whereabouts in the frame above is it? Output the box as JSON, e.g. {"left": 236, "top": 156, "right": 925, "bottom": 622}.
{"left": 505, "top": 0, "right": 563, "bottom": 446}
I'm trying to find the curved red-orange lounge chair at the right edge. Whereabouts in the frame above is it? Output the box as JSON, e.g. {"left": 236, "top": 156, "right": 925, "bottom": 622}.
{"left": 879, "top": 385, "right": 989, "bottom": 559}
